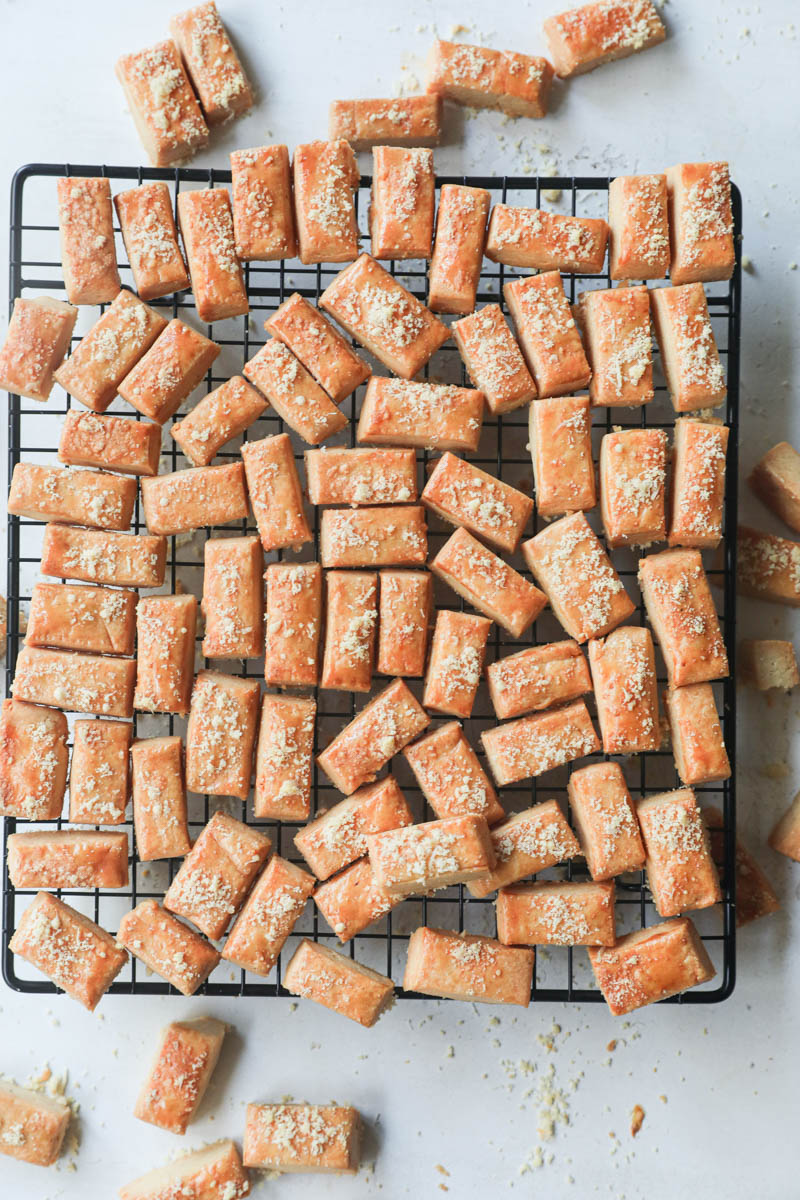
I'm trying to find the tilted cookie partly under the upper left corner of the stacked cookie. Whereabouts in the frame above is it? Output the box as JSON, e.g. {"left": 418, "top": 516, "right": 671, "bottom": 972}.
{"left": 294, "top": 775, "right": 414, "bottom": 880}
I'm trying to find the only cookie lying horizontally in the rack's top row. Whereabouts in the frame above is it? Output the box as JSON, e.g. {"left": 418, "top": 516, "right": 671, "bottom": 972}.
{"left": 486, "top": 204, "right": 608, "bottom": 275}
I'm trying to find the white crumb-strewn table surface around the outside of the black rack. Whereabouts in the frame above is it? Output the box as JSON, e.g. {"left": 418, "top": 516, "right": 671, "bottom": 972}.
{"left": 0, "top": 0, "right": 800, "bottom": 1200}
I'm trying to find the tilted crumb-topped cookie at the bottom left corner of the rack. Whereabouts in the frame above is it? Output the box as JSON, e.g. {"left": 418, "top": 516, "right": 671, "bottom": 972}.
{"left": 8, "top": 892, "right": 128, "bottom": 1013}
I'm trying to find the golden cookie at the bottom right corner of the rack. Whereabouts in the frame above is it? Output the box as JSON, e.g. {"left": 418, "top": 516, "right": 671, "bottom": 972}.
{"left": 589, "top": 917, "right": 716, "bottom": 1016}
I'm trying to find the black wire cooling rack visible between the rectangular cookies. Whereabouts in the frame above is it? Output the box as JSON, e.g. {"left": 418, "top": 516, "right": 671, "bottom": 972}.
{"left": 2, "top": 163, "right": 741, "bottom": 1004}
